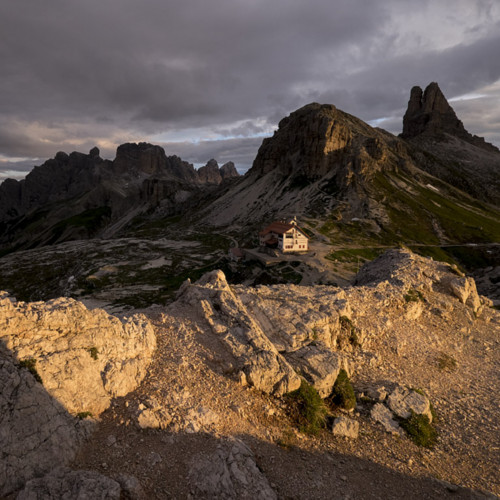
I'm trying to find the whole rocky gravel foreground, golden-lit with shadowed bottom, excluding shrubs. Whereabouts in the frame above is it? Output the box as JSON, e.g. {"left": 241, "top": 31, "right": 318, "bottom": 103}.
{"left": 0, "top": 251, "right": 500, "bottom": 498}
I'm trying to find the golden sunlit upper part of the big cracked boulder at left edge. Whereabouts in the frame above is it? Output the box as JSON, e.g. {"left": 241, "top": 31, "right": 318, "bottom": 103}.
{"left": 0, "top": 298, "right": 156, "bottom": 415}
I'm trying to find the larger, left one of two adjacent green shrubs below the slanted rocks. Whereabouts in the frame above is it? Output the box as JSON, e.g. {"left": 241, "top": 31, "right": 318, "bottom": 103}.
{"left": 287, "top": 380, "right": 328, "bottom": 434}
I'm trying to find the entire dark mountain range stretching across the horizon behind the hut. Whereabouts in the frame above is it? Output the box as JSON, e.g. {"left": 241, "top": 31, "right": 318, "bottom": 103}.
{"left": 0, "top": 83, "right": 500, "bottom": 253}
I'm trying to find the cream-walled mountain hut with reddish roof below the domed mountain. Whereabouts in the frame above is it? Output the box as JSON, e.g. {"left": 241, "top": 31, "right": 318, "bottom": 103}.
{"left": 259, "top": 219, "right": 309, "bottom": 253}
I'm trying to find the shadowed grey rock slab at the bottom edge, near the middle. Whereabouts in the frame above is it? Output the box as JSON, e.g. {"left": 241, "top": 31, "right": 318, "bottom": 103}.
{"left": 189, "top": 439, "right": 277, "bottom": 500}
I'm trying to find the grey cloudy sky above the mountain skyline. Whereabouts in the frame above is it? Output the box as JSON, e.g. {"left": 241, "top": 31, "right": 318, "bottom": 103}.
{"left": 0, "top": 0, "right": 500, "bottom": 180}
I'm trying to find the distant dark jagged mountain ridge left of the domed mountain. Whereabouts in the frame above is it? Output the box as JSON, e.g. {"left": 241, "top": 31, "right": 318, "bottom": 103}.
{"left": 0, "top": 143, "right": 239, "bottom": 254}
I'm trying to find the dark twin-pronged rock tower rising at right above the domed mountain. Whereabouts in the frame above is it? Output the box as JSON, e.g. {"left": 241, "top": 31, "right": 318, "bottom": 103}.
{"left": 401, "top": 82, "right": 498, "bottom": 152}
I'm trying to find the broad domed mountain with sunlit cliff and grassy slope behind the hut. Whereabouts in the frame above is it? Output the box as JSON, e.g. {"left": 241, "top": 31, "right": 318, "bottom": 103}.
{"left": 199, "top": 97, "right": 500, "bottom": 248}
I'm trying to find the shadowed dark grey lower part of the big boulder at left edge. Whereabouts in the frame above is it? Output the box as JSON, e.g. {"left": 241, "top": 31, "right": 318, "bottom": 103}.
{"left": 0, "top": 352, "right": 90, "bottom": 498}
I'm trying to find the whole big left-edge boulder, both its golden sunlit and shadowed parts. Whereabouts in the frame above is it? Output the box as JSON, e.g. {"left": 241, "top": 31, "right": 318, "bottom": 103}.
{"left": 0, "top": 292, "right": 156, "bottom": 498}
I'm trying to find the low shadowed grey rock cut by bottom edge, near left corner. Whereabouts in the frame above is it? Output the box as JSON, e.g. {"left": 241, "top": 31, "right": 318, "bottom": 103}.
{"left": 17, "top": 467, "right": 121, "bottom": 500}
